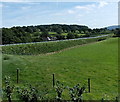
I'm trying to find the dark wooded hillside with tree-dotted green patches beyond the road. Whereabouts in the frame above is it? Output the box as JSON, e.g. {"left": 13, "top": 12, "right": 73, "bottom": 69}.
{"left": 2, "top": 24, "right": 115, "bottom": 44}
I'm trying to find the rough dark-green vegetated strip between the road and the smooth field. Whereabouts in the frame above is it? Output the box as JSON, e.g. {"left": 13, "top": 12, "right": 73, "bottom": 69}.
{"left": 2, "top": 37, "right": 107, "bottom": 55}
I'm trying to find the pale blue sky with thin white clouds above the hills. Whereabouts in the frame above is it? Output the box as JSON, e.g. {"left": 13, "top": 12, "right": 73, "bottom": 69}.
{"left": 0, "top": 0, "right": 118, "bottom": 28}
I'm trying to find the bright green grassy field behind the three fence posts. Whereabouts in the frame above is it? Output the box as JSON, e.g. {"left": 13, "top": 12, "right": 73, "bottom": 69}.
{"left": 3, "top": 38, "right": 118, "bottom": 100}
